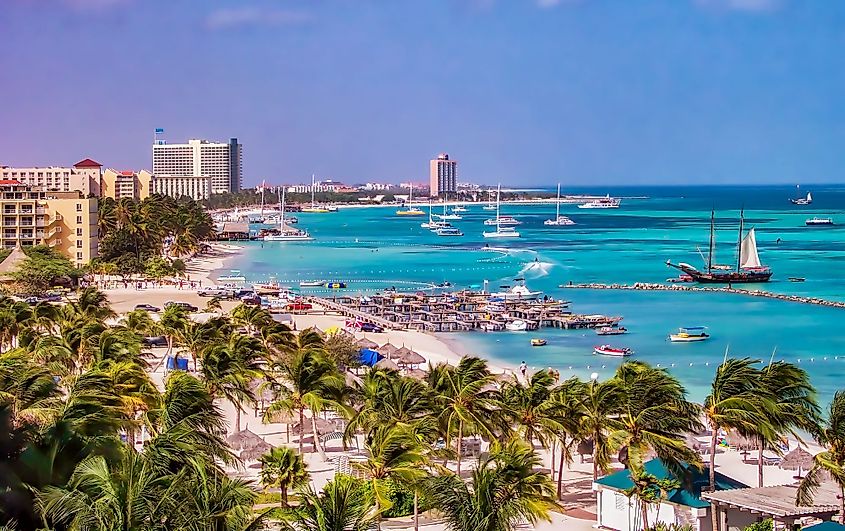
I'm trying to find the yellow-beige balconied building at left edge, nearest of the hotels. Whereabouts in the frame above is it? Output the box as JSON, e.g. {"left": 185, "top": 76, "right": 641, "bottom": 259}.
{"left": 0, "top": 179, "right": 98, "bottom": 266}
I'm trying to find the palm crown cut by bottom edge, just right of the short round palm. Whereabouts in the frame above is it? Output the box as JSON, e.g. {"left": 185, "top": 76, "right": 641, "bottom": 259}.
{"left": 282, "top": 474, "right": 375, "bottom": 531}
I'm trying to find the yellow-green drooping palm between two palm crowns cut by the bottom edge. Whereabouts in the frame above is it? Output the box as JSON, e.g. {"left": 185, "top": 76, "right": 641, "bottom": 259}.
{"left": 356, "top": 426, "right": 425, "bottom": 530}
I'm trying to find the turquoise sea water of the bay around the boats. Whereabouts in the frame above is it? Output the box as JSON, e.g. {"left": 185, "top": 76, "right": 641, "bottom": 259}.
{"left": 224, "top": 185, "right": 845, "bottom": 400}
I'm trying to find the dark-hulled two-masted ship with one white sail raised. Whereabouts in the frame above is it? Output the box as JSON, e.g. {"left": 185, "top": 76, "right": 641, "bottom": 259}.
{"left": 666, "top": 211, "right": 772, "bottom": 284}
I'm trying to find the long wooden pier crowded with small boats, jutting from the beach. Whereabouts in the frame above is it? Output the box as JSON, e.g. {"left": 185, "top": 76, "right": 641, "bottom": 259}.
{"left": 305, "top": 291, "right": 622, "bottom": 332}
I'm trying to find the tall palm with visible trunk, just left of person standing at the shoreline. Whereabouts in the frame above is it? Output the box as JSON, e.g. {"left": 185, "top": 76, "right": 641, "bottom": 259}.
{"left": 427, "top": 356, "right": 496, "bottom": 475}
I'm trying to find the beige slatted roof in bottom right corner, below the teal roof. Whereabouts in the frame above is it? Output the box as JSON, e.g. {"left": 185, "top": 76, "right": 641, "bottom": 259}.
{"left": 702, "top": 482, "right": 839, "bottom": 518}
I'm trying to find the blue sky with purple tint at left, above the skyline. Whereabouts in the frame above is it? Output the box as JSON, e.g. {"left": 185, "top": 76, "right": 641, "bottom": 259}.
{"left": 0, "top": 0, "right": 845, "bottom": 186}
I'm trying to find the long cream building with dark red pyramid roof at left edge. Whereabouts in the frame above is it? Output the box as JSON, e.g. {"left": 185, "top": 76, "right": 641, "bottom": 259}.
{"left": 0, "top": 159, "right": 103, "bottom": 196}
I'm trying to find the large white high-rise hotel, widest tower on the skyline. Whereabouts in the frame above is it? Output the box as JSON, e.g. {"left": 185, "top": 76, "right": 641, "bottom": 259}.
{"left": 153, "top": 138, "right": 243, "bottom": 194}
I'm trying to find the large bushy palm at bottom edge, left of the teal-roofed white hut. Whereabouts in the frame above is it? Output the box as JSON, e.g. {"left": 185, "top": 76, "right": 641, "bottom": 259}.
{"left": 426, "top": 440, "right": 559, "bottom": 531}
